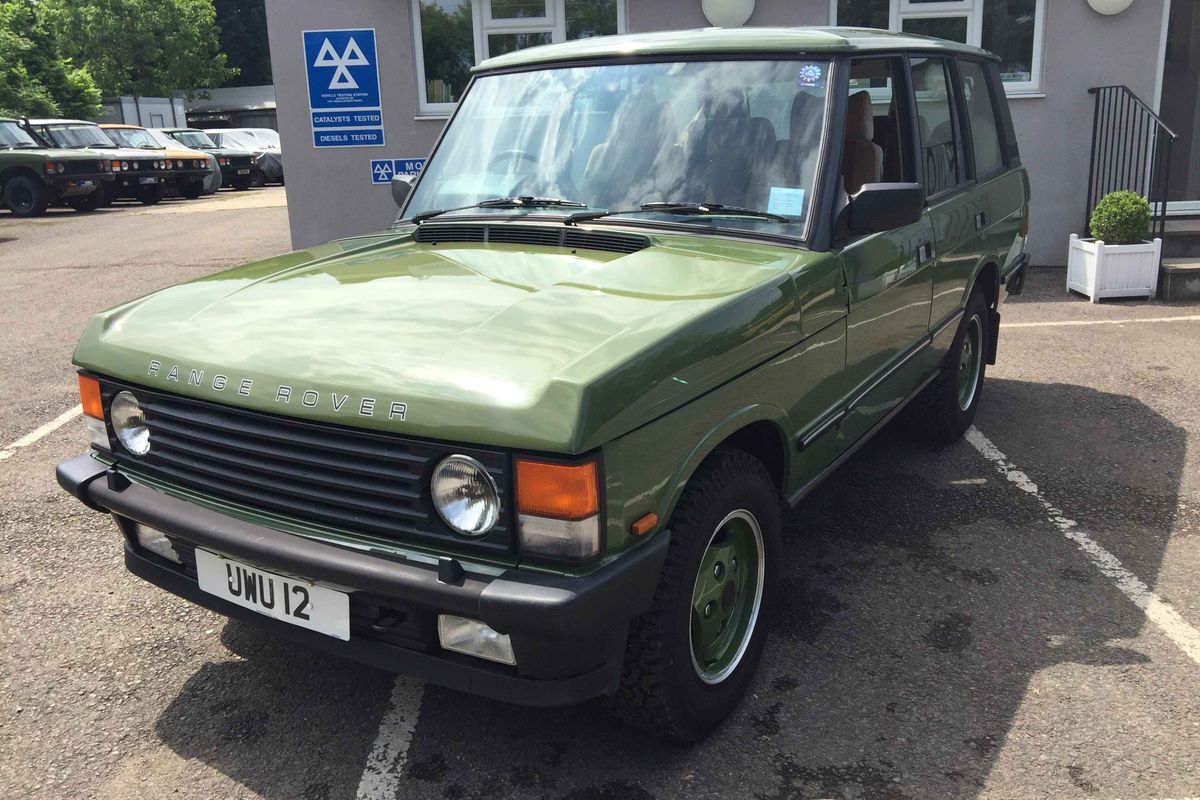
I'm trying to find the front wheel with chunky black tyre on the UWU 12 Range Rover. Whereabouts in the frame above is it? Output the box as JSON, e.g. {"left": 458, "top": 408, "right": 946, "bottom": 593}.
{"left": 607, "top": 449, "right": 781, "bottom": 741}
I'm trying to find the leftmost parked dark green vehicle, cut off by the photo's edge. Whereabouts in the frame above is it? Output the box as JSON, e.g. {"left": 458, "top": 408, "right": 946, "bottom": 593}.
{"left": 0, "top": 119, "right": 113, "bottom": 217}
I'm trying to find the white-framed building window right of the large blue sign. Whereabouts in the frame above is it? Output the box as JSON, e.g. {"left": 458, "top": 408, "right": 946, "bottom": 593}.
{"left": 410, "top": 0, "right": 625, "bottom": 115}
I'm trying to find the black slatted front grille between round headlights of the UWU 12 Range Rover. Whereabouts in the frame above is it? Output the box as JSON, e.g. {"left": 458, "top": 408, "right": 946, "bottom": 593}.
{"left": 103, "top": 383, "right": 514, "bottom": 553}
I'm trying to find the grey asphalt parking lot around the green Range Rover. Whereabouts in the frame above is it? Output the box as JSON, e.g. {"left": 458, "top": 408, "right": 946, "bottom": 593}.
{"left": 0, "top": 195, "right": 1200, "bottom": 800}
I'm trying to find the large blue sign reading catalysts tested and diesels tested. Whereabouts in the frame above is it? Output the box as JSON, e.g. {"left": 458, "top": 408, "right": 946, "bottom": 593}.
{"left": 304, "top": 28, "right": 385, "bottom": 148}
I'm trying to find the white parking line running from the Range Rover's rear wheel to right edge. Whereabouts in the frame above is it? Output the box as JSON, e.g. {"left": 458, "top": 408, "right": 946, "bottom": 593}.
{"left": 966, "top": 426, "right": 1200, "bottom": 664}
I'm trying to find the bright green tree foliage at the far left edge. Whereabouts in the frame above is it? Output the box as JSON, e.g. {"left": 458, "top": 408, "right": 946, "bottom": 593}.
{"left": 0, "top": 0, "right": 101, "bottom": 119}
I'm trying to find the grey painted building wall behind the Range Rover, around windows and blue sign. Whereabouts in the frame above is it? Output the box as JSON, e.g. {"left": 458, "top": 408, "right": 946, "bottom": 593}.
{"left": 266, "top": 0, "right": 1180, "bottom": 265}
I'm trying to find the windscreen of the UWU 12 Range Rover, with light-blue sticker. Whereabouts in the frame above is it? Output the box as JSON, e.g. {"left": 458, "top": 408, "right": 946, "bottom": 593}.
{"left": 406, "top": 60, "right": 829, "bottom": 237}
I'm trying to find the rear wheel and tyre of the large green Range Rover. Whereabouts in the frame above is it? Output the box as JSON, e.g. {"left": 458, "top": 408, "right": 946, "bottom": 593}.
{"left": 913, "top": 287, "right": 991, "bottom": 444}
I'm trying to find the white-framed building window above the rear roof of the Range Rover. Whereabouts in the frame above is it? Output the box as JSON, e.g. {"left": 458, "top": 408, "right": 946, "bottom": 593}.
{"left": 829, "top": 0, "right": 1046, "bottom": 95}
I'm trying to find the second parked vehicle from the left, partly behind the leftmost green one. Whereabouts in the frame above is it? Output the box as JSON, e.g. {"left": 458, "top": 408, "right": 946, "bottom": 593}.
{"left": 29, "top": 120, "right": 169, "bottom": 205}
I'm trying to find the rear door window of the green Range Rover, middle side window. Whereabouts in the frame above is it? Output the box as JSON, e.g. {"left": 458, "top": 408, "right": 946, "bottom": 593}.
{"left": 910, "top": 58, "right": 966, "bottom": 197}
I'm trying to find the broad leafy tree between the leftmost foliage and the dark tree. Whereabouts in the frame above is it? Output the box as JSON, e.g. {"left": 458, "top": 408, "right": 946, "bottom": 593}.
{"left": 40, "top": 0, "right": 236, "bottom": 97}
